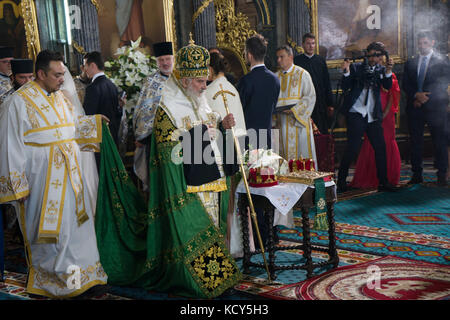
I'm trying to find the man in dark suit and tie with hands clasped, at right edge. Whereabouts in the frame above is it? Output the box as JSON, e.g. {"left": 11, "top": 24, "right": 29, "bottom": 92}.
{"left": 402, "top": 32, "right": 450, "bottom": 186}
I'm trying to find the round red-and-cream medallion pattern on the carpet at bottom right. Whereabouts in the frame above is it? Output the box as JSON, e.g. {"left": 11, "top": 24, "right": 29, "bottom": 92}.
{"left": 263, "top": 256, "right": 450, "bottom": 300}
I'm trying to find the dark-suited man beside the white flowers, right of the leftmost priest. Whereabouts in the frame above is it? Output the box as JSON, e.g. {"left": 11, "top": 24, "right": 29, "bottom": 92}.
{"left": 83, "top": 51, "right": 122, "bottom": 169}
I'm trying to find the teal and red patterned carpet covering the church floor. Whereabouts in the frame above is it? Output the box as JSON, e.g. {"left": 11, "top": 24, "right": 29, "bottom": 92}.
{"left": 0, "top": 160, "right": 450, "bottom": 300}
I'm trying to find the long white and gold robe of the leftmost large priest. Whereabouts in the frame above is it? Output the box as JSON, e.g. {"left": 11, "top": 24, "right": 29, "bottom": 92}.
{"left": 0, "top": 81, "right": 107, "bottom": 298}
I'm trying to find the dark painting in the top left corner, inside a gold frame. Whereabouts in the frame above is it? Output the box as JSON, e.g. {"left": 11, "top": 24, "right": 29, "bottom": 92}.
{"left": 0, "top": 0, "right": 28, "bottom": 58}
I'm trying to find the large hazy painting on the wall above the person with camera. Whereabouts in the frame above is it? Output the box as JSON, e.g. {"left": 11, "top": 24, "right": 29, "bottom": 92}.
{"left": 312, "top": 0, "right": 403, "bottom": 67}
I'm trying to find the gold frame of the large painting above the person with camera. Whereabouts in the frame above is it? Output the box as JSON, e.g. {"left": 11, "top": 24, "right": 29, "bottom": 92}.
{"left": 310, "top": 0, "right": 406, "bottom": 68}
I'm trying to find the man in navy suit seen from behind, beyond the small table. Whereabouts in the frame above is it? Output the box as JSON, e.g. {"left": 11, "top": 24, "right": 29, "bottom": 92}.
{"left": 237, "top": 34, "right": 280, "bottom": 149}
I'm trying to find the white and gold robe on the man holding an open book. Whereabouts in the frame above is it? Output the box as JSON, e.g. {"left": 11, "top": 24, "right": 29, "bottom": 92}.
{"left": 276, "top": 65, "right": 317, "bottom": 166}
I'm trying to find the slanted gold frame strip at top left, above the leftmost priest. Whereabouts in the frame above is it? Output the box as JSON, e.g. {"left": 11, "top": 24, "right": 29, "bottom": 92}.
{"left": 20, "top": 0, "right": 41, "bottom": 60}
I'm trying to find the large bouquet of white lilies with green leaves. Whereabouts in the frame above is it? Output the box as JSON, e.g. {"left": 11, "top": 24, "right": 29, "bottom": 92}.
{"left": 105, "top": 37, "right": 157, "bottom": 112}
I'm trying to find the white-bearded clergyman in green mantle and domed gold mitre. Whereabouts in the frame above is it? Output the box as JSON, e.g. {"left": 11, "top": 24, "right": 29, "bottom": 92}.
{"left": 97, "top": 36, "right": 241, "bottom": 299}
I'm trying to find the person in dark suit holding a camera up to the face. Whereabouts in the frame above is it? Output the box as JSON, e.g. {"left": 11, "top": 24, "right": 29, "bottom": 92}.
{"left": 337, "top": 42, "right": 396, "bottom": 192}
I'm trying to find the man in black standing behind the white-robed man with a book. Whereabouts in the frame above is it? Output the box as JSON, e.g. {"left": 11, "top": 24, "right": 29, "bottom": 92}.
{"left": 294, "top": 33, "right": 334, "bottom": 134}
